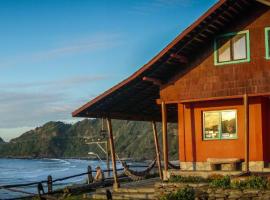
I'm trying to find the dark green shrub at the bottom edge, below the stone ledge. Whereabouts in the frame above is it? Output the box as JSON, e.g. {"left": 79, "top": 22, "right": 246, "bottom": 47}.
{"left": 160, "top": 188, "right": 195, "bottom": 200}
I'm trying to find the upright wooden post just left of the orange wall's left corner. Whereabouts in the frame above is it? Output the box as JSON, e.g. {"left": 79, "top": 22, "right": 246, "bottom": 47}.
{"left": 161, "top": 102, "right": 168, "bottom": 180}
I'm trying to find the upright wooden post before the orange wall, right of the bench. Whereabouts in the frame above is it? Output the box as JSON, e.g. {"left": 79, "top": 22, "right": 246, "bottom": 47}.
{"left": 244, "top": 94, "right": 249, "bottom": 172}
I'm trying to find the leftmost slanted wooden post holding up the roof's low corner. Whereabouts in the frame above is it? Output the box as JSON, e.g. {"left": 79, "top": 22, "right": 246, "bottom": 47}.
{"left": 107, "top": 118, "right": 120, "bottom": 189}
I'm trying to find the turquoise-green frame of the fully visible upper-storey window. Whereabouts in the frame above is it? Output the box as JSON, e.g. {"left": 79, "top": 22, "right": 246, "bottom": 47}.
{"left": 214, "top": 30, "right": 250, "bottom": 65}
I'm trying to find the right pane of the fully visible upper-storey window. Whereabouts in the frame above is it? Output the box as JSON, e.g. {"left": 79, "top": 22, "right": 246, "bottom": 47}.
{"left": 232, "top": 34, "right": 247, "bottom": 60}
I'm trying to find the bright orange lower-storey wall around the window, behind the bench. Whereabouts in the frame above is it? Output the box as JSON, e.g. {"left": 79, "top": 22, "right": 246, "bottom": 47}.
{"left": 178, "top": 97, "right": 264, "bottom": 162}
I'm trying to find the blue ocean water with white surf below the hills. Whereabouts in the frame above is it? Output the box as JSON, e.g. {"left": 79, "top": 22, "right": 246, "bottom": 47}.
{"left": 0, "top": 159, "right": 127, "bottom": 200}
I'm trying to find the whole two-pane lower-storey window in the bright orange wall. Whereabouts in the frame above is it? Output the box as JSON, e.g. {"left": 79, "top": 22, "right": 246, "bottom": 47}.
{"left": 203, "top": 110, "right": 237, "bottom": 140}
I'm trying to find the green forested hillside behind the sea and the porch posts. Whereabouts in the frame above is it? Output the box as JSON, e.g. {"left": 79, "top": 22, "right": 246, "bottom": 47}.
{"left": 0, "top": 119, "right": 178, "bottom": 159}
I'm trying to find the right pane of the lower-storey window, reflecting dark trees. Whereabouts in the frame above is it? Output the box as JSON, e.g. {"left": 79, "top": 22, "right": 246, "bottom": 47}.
{"left": 221, "top": 110, "right": 236, "bottom": 138}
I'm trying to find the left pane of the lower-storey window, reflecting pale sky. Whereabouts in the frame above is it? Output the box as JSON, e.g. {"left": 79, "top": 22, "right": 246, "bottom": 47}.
{"left": 204, "top": 112, "right": 220, "bottom": 139}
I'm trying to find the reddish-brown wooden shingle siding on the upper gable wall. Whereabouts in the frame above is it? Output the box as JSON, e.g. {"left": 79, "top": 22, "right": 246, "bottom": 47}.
{"left": 160, "top": 5, "right": 270, "bottom": 101}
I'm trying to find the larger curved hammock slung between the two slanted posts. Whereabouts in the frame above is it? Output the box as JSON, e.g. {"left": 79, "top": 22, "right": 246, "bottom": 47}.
{"left": 120, "top": 159, "right": 157, "bottom": 181}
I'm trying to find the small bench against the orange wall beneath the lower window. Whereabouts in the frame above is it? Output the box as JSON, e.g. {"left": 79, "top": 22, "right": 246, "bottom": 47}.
{"left": 207, "top": 158, "right": 241, "bottom": 171}
